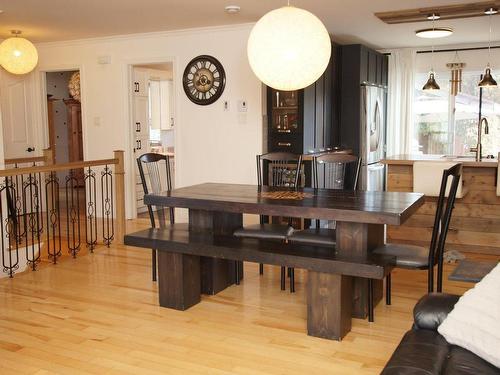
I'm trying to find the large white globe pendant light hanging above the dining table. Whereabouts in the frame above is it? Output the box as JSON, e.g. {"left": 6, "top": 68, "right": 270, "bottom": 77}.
{"left": 247, "top": 6, "right": 332, "bottom": 91}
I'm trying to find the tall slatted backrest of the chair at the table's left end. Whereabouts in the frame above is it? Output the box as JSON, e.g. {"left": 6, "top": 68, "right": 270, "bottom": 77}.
{"left": 137, "top": 152, "right": 175, "bottom": 228}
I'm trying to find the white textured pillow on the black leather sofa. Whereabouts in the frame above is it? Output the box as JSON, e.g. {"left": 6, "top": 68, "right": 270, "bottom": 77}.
{"left": 438, "top": 263, "right": 500, "bottom": 367}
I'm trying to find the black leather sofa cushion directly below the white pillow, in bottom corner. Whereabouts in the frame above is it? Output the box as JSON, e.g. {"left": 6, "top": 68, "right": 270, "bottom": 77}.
{"left": 443, "top": 345, "right": 500, "bottom": 375}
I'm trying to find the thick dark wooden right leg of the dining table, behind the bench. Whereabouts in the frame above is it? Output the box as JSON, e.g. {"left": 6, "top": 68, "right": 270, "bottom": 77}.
{"left": 336, "top": 221, "right": 384, "bottom": 319}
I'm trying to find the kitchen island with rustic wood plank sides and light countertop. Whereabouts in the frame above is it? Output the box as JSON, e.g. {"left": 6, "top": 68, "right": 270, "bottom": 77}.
{"left": 383, "top": 155, "right": 500, "bottom": 255}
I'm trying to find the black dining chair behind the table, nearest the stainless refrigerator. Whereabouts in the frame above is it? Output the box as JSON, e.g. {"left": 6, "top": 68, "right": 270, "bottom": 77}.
{"left": 288, "top": 152, "right": 361, "bottom": 247}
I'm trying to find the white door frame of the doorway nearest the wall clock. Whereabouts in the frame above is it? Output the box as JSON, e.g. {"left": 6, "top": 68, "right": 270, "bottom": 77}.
{"left": 122, "top": 55, "right": 180, "bottom": 219}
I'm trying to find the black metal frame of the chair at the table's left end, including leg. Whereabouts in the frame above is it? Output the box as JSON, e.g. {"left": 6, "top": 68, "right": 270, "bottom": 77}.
{"left": 137, "top": 152, "right": 175, "bottom": 281}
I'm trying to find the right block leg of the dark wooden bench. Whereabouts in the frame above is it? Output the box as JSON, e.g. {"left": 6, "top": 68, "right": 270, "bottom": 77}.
{"left": 307, "top": 271, "right": 352, "bottom": 341}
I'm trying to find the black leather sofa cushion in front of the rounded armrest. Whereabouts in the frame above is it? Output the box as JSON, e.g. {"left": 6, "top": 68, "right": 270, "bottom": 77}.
{"left": 382, "top": 329, "right": 449, "bottom": 375}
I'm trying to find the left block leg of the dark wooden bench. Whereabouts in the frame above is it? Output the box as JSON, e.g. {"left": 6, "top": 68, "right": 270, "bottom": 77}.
{"left": 158, "top": 251, "right": 201, "bottom": 310}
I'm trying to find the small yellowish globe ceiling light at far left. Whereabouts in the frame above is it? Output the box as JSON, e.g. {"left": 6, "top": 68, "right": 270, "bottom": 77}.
{"left": 0, "top": 30, "right": 38, "bottom": 74}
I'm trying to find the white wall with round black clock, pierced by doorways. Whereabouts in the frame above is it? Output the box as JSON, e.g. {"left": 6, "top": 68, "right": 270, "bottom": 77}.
{"left": 26, "top": 25, "right": 262, "bottom": 217}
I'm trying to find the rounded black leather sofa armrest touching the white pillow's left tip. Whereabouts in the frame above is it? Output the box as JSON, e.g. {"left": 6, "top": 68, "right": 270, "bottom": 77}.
{"left": 413, "top": 293, "right": 460, "bottom": 330}
